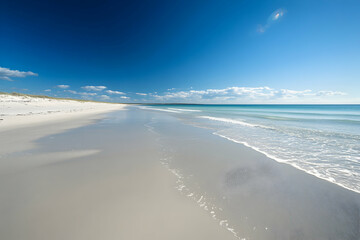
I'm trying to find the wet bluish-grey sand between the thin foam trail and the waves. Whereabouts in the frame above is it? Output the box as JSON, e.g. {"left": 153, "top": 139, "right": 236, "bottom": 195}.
{"left": 146, "top": 109, "right": 360, "bottom": 240}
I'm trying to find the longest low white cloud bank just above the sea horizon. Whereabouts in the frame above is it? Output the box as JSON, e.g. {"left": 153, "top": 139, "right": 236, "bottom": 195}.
{"left": 152, "top": 87, "right": 345, "bottom": 103}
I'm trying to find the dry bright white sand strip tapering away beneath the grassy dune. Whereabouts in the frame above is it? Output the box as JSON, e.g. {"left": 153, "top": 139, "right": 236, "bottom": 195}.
{"left": 0, "top": 94, "right": 125, "bottom": 132}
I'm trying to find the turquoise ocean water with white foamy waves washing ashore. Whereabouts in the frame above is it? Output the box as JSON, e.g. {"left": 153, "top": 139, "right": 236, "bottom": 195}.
{"left": 139, "top": 105, "right": 360, "bottom": 193}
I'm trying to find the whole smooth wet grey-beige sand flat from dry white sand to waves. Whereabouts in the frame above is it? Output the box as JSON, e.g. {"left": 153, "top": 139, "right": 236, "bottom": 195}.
{"left": 0, "top": 96, "right": 360, "bottom": 240}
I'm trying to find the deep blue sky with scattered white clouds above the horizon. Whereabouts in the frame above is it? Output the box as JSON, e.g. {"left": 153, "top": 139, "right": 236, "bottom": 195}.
{"left": 0, "top": 0, "right": 360, "bottom": 104}
